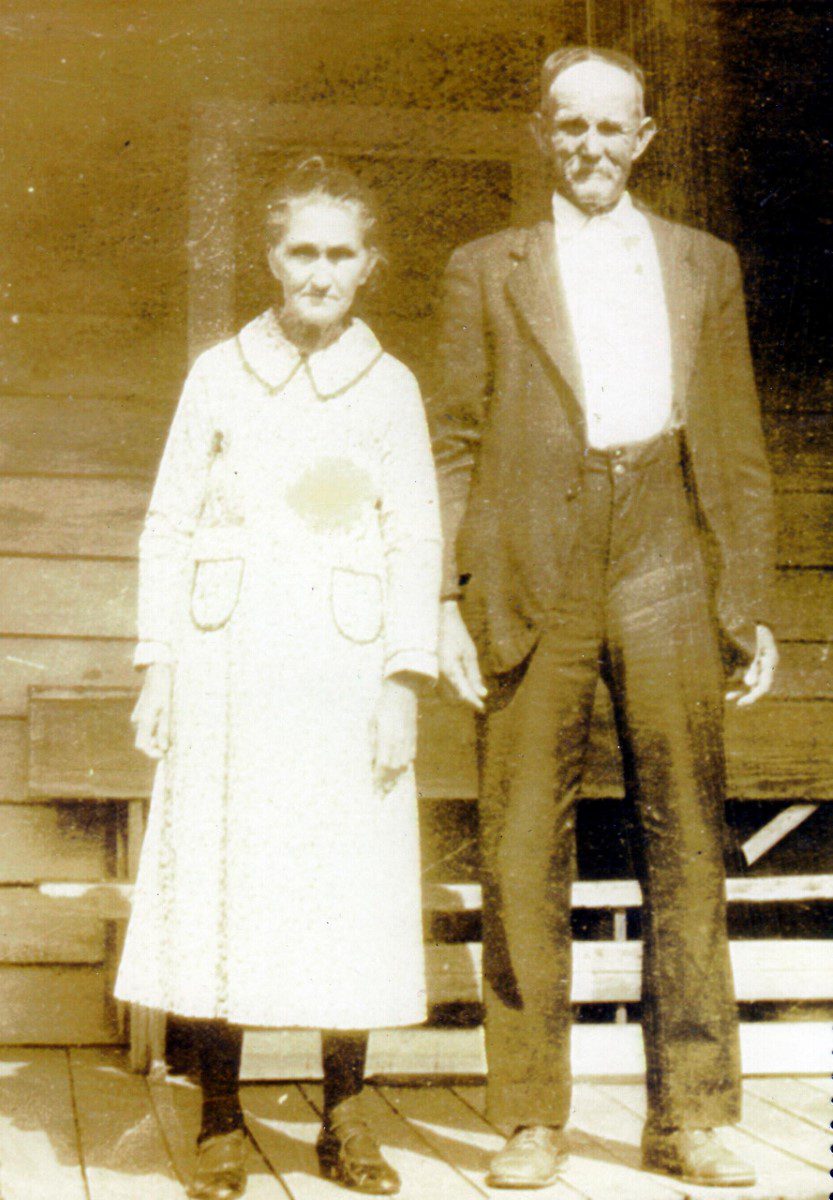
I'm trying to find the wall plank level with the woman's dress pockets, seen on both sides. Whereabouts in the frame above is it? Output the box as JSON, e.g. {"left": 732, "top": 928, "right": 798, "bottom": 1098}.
{"left": 0, "top": 557, "right": 833, "bottom": 642}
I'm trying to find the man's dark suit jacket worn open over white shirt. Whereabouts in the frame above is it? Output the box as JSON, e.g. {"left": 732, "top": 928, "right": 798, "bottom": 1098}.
{"left": 429, "top": 207, "right": 774, "bottom": 672}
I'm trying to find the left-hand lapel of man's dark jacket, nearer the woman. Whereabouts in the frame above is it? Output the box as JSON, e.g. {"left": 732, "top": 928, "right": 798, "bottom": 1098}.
{"left": 507, "top": 221, "right": 585, "bottom": 439}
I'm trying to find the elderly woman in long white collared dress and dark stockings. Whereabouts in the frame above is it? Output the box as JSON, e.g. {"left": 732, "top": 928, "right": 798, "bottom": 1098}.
{"left": 116, "top": 158, "right": 441, "bottom": 1200}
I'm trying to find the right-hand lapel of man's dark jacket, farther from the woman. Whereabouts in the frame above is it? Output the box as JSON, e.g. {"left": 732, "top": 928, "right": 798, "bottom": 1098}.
{"left": 645, "top": 212, "right": 705, "bottom": 421}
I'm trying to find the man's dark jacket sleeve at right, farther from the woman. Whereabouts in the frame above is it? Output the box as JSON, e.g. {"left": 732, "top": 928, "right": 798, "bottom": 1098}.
{"left": 693, "top": 244, "right": 775, "bottom": 654}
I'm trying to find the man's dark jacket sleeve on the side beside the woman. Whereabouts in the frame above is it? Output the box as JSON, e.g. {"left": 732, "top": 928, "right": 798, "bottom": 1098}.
{"left": 427, "top": 246, "right": 490, "bottom": 599}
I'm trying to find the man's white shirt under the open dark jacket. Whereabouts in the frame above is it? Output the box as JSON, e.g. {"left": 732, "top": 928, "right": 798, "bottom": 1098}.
{"left": 552, "top": 192, "right": 672, "bottom": 450}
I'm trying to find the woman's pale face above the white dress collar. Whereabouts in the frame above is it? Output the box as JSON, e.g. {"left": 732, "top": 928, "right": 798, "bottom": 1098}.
{"left": 269, "top": 198, "right": 376, "bottom": 330}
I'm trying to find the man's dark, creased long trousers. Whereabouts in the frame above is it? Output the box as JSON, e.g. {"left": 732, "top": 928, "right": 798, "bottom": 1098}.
{"left": 479, "top": 436, "right": 739, "bottom": 1130}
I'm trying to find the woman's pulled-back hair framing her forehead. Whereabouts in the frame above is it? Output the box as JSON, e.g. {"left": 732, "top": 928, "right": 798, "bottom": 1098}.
{"left": 266, "top": 155, "right": 382, "bottom": 254}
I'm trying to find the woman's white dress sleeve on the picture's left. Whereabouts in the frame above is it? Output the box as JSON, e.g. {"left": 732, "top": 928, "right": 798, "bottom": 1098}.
{"left": 133, "top": 360, "right": 215, "bottom": 667}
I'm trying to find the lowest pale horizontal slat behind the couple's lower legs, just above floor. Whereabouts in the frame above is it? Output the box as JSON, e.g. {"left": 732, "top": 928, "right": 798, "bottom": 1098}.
{"left": 241, "top": 1021, "right": 829, "bottom": 1080}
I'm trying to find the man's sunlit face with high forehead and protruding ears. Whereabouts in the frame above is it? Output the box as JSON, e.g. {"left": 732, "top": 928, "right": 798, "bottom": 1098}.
{"left": 534, "top": 60, "right": 657, "bottom": 215}
